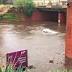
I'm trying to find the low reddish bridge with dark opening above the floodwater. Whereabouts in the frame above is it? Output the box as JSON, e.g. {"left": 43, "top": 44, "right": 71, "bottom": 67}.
{"left": 32, "top": 7, "right": 67, "bottom": 24}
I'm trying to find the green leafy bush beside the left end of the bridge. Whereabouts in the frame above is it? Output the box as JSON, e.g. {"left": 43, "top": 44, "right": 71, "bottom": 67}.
{"left": 13, "top": 0, "right": 35, "bottom": 16}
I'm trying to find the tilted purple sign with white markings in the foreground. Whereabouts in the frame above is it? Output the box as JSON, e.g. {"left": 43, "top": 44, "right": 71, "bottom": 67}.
{"left": 6, "top": 50, "right": 28, "bottom": 68}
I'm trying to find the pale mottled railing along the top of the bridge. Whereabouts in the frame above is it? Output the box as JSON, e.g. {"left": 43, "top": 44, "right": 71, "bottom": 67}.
{"left": 33, "top": 0, "right": 67, "bottom": 8}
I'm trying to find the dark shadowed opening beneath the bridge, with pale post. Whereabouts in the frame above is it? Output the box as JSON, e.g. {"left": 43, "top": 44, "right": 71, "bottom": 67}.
{"left": 37, "top": 8, "right": 67, "bottom": 23}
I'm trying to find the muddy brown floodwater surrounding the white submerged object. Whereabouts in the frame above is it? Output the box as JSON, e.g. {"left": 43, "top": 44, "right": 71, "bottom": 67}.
{"left": 0, "top": 23, "right": 65, "bottom": 72}
